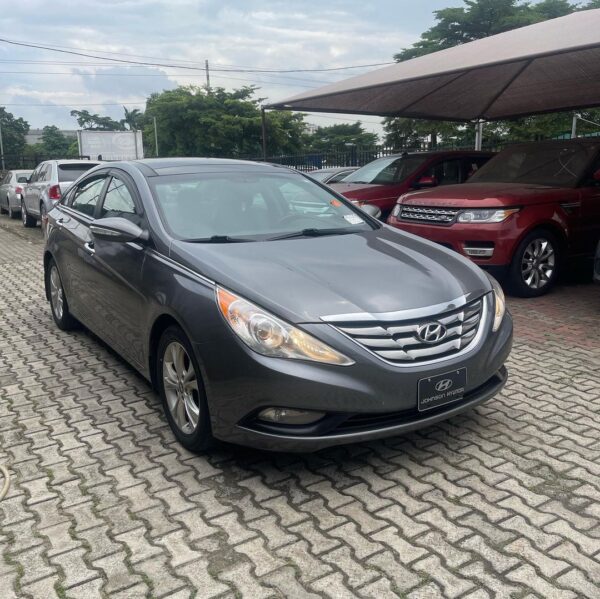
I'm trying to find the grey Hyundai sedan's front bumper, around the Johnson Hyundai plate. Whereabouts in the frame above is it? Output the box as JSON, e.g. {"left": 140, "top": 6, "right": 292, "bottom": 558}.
{"left": 195, "top": 312, "right": 512, "bottom": 452}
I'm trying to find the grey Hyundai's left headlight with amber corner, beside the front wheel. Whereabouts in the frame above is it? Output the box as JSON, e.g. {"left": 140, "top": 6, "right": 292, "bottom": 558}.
{"left": 217, "top": 287, "right": 354, "bottom": 366}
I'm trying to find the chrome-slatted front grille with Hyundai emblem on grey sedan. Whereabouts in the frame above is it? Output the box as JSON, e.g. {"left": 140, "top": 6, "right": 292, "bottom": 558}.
{"left": 332, "top": 298, "right": 485, "bottom": 364}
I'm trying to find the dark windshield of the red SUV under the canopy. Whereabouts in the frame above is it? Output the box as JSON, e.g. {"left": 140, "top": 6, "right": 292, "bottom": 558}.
{"left": 467, "top": 142, "right": 598, "bottom": 187}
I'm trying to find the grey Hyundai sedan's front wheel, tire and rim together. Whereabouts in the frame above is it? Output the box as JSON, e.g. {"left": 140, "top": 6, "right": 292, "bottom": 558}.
{"left": 156, "top": 326, "right": 214, "bottom": 453}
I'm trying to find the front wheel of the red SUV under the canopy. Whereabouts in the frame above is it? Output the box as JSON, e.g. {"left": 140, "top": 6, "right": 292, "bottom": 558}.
{"left": 509, "top": 229, "right": 561, "bottom": 297}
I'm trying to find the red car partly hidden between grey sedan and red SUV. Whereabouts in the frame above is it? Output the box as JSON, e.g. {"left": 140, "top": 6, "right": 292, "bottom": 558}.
{"left": 333, "top": 151, "right": 494, "bottom": 218}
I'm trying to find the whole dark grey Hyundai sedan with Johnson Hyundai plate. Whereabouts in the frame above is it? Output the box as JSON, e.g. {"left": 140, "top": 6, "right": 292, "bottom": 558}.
{"left": 44, "top": 158, "right": 512, "bottom": 451}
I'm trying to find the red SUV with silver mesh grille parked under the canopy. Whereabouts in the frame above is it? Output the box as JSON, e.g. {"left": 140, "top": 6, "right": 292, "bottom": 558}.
{"left": 388, "top": 139, "right": 600, "bottom": 297}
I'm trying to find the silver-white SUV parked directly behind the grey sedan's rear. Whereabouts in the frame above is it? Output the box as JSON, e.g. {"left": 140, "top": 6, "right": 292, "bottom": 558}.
{"left": 21, "top": 160, "right": 99, "bottom": 234}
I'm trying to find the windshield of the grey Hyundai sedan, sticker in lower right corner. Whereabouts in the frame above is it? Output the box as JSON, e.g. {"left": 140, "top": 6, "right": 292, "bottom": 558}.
{"left": 148, "top": 171, "right": 377, "bottom": 242}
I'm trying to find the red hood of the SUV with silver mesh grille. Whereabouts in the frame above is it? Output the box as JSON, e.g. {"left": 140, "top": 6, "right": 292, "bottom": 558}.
{"left": 402, "top": 183, "right": 577, "bottom": 208}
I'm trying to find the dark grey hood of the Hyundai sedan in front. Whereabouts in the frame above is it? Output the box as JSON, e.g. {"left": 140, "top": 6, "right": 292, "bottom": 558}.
{"left": 171, "top": 226, "right": 491, "bottom": 323}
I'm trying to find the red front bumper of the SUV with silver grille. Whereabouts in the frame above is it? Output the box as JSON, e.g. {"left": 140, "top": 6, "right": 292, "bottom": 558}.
{"left": 387, "top": 216, "right": 519, "bottom": 267}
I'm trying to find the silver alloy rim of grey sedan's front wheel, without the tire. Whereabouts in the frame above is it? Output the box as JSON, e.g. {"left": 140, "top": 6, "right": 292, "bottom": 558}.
{"left": 162, "top": 341, "right": 200, "bottom": 435}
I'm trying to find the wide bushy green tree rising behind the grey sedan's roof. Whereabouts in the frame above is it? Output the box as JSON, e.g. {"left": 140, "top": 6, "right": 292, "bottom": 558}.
{"left": 144, "top": 86, "right": 305, "bottom": 157}
